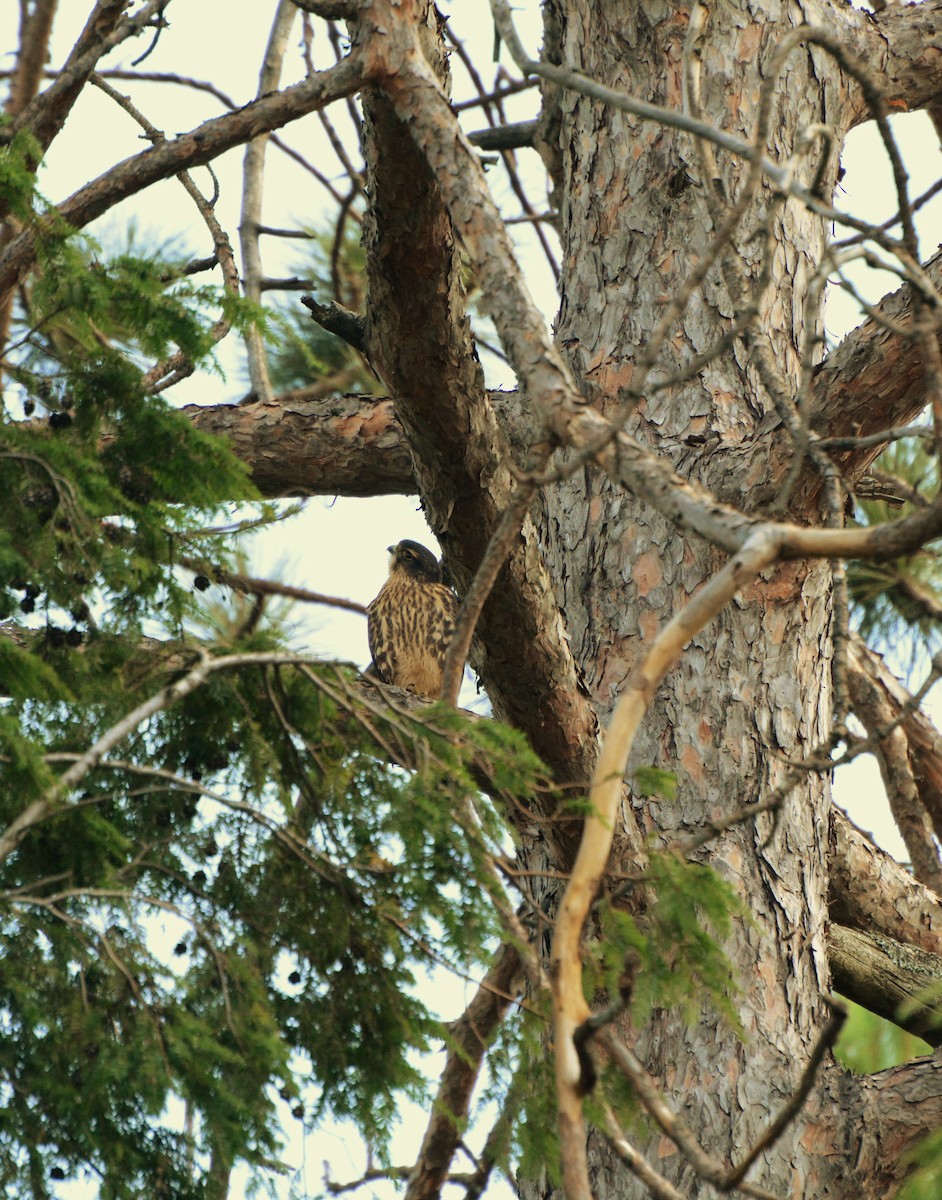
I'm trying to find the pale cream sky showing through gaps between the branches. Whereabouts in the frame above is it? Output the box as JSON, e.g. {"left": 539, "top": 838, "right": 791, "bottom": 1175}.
{"left": 0, "top": 0, "right": 942, "bottom": 1193}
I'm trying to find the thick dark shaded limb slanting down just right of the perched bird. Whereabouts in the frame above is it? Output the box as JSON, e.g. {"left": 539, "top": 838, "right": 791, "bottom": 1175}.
{"left": 362, "top": 4, "right": 596, "bottom": 801}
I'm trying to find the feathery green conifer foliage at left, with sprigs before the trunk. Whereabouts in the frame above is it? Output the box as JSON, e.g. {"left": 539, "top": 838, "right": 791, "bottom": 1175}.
{"left": 0, "top": 201, "right": 758, "bottom": 1200}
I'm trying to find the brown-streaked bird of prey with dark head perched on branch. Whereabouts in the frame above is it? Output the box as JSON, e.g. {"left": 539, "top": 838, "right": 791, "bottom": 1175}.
{"left": 366, "top": 539, "right": 458, "bottom": 700}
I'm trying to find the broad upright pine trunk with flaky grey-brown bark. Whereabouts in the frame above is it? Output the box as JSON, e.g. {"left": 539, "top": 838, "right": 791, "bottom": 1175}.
{"left": 528, "top": 0, "right": 851, "bottom": 1198}
